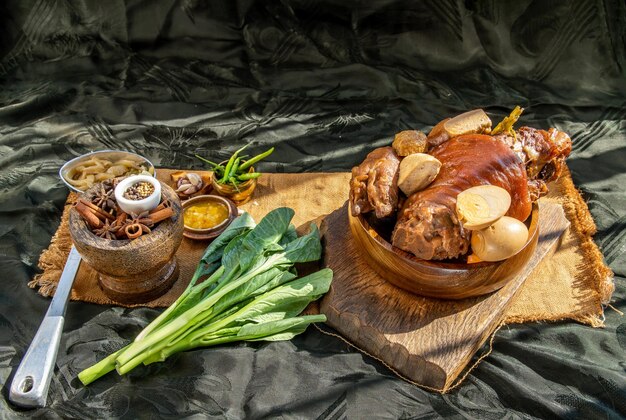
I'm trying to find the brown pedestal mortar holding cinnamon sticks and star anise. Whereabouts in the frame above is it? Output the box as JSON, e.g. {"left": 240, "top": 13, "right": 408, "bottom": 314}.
{"left": 69, "top": 183, "right": 183, "bottom": 303}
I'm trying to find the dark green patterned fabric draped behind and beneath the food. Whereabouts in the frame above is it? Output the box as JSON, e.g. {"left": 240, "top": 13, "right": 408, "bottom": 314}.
{"left": 0, "top": 0, "right": 626, "bottom": 419}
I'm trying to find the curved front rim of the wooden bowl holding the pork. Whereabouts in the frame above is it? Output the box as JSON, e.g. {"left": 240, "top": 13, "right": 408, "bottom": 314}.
{"left": 348, "top": 202, "right": 539, "bottom": 271}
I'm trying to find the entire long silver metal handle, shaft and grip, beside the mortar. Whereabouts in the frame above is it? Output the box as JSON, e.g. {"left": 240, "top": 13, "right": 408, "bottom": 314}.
{"left": 9, "top": 246, "right": 81, "bottom": 407}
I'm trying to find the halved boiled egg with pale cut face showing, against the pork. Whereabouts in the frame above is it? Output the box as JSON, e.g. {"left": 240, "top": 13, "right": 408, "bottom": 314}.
{"left": 456, "top": 185, "right": 511, "bottom": 230}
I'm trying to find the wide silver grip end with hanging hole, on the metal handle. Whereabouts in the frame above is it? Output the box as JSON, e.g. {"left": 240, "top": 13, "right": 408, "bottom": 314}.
{"left": 9, "top": 316, "right": 65, "bottom": 407}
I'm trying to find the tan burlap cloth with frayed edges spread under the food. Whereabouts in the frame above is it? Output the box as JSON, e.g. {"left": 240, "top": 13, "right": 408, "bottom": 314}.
{"left": 29, "top": 169, "right": 614, "bottom": 327}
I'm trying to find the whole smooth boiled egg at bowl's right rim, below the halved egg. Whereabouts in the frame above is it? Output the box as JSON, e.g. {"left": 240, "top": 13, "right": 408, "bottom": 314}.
{"left": 470, "top": 216, "right": 528, "bottom": 261}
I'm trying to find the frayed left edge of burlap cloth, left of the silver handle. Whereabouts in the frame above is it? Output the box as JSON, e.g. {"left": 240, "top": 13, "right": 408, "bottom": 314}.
{"left": 28, "top": 193, "right": 76, "bottom": 297}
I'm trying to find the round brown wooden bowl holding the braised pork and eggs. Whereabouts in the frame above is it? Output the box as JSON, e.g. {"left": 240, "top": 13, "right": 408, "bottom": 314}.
{"left": 348, "top": 204, "right": 539, "bottom": 299}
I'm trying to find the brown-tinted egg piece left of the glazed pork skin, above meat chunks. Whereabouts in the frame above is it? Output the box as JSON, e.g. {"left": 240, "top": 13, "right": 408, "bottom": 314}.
{"left": 398, "top": 153, "right": 441, "bottom": 197}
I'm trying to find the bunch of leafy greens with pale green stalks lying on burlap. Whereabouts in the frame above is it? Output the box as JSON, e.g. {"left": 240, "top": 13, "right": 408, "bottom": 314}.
{"left": 78, "top": 206, "right": 332, "bottom": 385}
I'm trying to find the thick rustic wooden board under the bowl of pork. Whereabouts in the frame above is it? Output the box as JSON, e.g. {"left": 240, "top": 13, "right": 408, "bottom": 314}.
{"left": 320, "top": 202, "right": 569, "bottom": 392}
